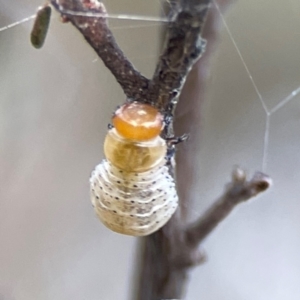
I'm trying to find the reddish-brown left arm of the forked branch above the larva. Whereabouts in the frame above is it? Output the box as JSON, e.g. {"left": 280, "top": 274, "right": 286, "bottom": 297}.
{"left": 51, "top": 0, "right": 149, "bottom": 101}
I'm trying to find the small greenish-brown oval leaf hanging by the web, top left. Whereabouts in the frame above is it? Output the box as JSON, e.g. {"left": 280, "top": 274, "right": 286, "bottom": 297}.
{"left": 30, "top": 4, "right": 51, "bottom": 49}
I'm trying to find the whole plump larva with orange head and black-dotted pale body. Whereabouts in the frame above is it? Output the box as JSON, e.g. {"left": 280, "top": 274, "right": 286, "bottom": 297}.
{"left": 90, "top": 102, "right": 178, "bottom": 236}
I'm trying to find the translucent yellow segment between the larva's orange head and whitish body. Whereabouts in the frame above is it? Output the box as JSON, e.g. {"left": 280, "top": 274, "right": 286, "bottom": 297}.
{"left": 104, "top": 129, "right": 167, "bottom": 172}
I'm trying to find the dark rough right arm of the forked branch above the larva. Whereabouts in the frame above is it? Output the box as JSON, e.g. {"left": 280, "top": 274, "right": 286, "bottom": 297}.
{"left": 150, "top": 0, "right": 211, "bottom": 112}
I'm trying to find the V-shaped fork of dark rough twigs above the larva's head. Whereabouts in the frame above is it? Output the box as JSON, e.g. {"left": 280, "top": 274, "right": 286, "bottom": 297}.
{"left": 51, "top": 0, "right": 211, "bottom": 114}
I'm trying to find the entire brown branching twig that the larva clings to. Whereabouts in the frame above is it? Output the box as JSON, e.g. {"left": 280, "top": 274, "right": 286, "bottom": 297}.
{"left": 47, "top": 0, "right": 271, "bottom": 300}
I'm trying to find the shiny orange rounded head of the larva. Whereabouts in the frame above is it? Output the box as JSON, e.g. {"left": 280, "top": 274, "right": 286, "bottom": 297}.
{"left": 112, "top": 102, "right": 163, "bottom": 141}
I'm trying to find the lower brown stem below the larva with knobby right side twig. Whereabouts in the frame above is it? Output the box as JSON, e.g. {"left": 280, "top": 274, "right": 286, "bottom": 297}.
{"left": 135, "top": 170, "right": 271, "bottom": 300}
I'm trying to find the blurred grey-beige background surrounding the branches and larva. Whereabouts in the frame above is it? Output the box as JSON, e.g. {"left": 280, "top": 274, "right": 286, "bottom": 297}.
{"left": 0, "top": 0, "right": 300, "bottom": 300}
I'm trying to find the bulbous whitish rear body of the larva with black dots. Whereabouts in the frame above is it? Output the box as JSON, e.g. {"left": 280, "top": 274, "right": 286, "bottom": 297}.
{"left": 90, "top": 160, "right": 178, "bottom": 236}
